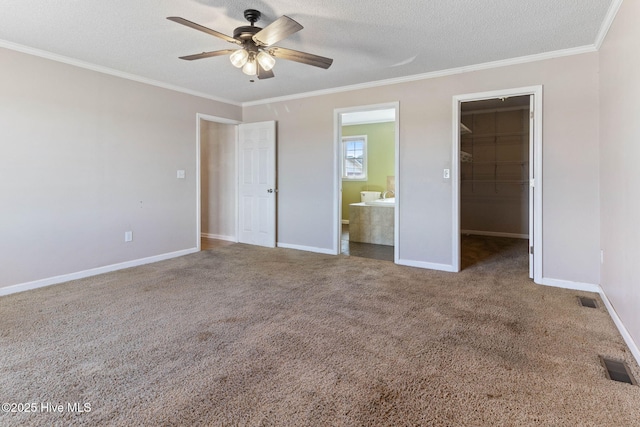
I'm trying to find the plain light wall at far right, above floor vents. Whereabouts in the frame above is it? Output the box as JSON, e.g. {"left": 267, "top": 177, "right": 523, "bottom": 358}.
{"left": 600, "top": 1, "right": 640, "bottom": 357}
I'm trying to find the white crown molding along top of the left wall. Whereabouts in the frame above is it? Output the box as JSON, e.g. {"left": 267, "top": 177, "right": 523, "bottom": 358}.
{"left": 0, "top": 40, "right": 242, "bottom": 107}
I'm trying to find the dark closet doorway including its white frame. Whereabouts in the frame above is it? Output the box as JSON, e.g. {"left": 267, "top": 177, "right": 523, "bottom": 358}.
{"left": 452, "top": 87, "right": 542, "bottom": 281}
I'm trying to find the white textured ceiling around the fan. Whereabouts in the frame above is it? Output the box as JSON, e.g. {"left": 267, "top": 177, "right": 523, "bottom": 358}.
{"left": 0, "top": 0, "right": 615, "bottom": 103}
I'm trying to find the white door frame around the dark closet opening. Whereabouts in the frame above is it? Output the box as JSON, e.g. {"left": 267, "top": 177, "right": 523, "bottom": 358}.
{"left": 451, "top": 85, "right": 544, "bottom": 283}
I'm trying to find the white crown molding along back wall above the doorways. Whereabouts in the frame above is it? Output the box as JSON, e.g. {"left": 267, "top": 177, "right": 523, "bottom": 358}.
{"left": 242, "top": 45, "right": 597, "bottom": 108}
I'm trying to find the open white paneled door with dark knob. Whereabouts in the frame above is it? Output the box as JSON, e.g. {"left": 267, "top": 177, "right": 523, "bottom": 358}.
{"left": 238, "top": 121, "right": 277, "bottom": 247}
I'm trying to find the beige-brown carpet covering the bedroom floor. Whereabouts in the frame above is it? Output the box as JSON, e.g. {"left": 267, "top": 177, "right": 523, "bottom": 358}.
{"left": 0, "top": 239, "right": 640, "bottom": 426}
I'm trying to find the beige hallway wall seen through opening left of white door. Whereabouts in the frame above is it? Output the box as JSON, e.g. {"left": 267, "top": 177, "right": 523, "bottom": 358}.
{"left": 200, "top": 120, "right": 237, "bottom": 240}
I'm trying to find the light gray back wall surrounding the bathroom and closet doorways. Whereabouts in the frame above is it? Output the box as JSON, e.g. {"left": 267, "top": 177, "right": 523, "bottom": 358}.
{"left": 243, "top": 53, "right": 600, "bottom": 284}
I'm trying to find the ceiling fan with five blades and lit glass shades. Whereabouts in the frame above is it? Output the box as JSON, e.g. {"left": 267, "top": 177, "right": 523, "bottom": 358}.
{"left": 167, "top": 9, "right": 333, "bottom": 79}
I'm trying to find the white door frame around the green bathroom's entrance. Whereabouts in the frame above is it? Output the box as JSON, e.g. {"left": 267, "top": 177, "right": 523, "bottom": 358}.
{"left": 333, "top": 101, "right": 401, "bottom": 264}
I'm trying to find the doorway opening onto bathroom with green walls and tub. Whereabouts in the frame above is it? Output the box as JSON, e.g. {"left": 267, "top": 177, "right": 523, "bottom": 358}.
{"left": 335, "top": 103, "right": 399, "bottom": 262}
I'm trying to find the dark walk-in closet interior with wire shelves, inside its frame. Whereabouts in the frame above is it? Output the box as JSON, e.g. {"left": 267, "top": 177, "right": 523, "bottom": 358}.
{"left": 459, "top": 95, "right": 533, "bottom": 277}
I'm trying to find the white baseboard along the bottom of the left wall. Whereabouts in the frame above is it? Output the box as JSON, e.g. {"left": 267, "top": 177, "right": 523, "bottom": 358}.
{"left": 0, "top": 248, "right": 198, "bottom": 296}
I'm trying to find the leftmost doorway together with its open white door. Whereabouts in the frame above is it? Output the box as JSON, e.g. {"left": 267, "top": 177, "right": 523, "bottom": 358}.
{"left": 196, "top": 114, "right": 278, "bottom": 249}
